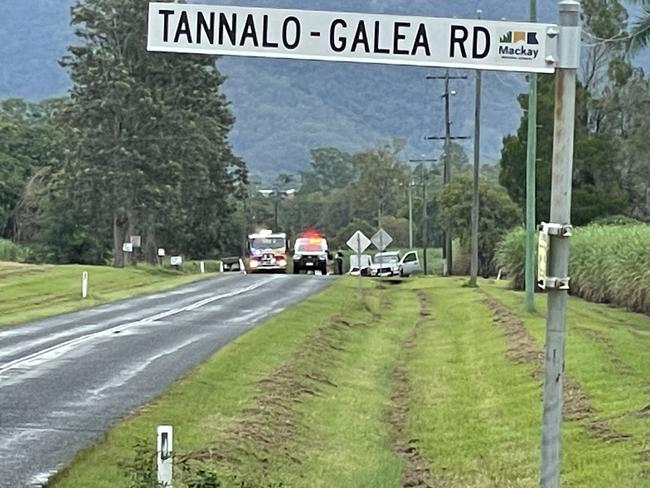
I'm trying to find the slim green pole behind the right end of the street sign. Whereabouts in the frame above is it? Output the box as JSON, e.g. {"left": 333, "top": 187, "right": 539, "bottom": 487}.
{"left": 524, "top": 0, "right": 537, "bottom": 312}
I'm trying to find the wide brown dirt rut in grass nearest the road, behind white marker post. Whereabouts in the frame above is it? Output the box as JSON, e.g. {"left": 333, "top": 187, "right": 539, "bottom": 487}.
{"left": 180, "top": 317, "right": 368, "bottom": 479}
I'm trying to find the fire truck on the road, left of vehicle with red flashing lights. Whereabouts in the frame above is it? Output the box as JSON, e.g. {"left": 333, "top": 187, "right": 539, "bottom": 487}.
{"left": 246, "top": 230, "right": 289, "bottom": 273}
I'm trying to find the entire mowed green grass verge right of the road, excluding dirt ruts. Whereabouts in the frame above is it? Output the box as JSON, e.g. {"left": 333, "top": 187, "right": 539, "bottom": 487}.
{"left": 49, "top": 278, "right": 650, "bottom": 488}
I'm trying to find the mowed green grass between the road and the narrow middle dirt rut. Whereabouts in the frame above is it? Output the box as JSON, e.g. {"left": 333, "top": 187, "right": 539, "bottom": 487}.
{"left": 48, "top": 279, "right": 410, "bottom": 488}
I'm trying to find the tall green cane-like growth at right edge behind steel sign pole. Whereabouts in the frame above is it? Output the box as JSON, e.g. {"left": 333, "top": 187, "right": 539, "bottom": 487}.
{"left": 496, "top": 224, "right": 650, "bottom": 314}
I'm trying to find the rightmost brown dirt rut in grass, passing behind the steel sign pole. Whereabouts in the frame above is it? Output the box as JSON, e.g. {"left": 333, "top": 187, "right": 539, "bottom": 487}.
{"left": 480, "top": 291, "right": 631, "bottom": 442}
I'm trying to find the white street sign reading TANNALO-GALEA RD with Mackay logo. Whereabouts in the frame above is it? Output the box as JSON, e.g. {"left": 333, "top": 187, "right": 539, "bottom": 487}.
{"left": 147, "top": 2, "right": 556, "bottom": 73}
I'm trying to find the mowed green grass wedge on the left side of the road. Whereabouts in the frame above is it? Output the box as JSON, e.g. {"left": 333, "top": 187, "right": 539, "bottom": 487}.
{"left": 0, "top": 261, "right": 206, "bottom": 327}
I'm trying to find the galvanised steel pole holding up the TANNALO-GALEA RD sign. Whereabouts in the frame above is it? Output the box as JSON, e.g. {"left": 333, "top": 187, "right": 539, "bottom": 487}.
{"left": 539, "top": 0, "right": 580, "bottom": 488}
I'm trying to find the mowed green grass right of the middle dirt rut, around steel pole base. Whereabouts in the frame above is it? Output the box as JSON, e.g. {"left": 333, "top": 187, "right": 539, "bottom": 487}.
{"left": 409, "top": 279, "right": 650, "bottom": 488}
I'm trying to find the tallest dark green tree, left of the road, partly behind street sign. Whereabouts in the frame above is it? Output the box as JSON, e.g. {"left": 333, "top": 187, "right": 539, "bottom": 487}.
{"left": 61, "top": 0, "right": 246, "bottom": 265}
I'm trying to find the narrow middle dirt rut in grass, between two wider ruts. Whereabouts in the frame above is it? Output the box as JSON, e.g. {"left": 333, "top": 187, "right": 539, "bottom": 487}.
{"left": 386, "top": 290, "right": 449, "bottom": 488}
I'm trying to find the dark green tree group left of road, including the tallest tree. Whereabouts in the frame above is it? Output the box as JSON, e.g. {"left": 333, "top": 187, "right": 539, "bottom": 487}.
{"left": 0, "top": 0, "right": 247, "bottom": 266}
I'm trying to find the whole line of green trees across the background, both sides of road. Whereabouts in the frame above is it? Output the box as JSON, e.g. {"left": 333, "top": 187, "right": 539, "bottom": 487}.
{"left": 0, "top": 0, "right": 650, "bottom": 274}
